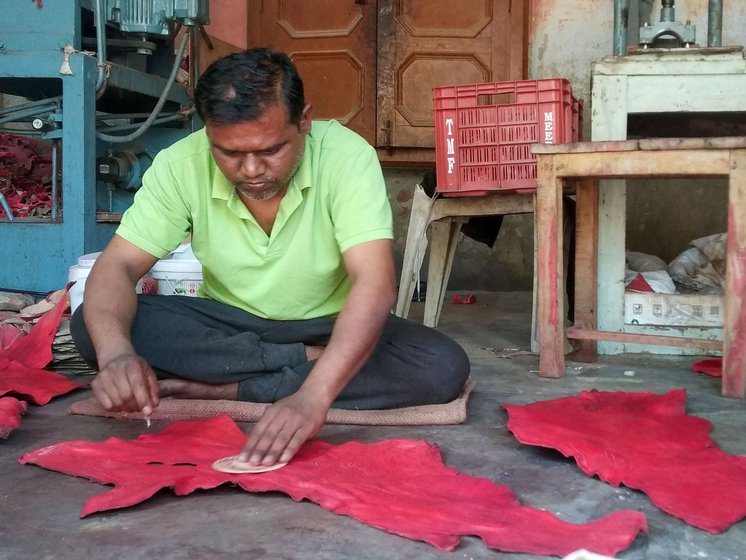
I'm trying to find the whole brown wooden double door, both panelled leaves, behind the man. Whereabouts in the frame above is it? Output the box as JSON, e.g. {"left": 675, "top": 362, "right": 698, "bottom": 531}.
{"left": 246, "top": 0, "right": 527, "bottom": 158}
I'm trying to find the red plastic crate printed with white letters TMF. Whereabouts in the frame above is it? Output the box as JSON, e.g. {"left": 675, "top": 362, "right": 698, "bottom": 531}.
{"left": 433, "top": 78, "right": 582, "bottom": 196}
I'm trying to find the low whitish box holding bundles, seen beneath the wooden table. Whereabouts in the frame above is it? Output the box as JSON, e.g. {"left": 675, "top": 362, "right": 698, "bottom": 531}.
{"left": 624, "top": 292, "right": 723, "bottom": 327}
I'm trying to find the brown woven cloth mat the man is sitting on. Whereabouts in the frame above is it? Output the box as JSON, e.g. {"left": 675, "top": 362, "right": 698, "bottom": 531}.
{"left": 67, "top": 379, "right": 475, "bottom": 426}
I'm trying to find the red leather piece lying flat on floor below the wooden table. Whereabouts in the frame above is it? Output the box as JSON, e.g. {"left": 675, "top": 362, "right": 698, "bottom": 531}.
{"left": 504, "top": 389, "right": 746, "bottom": 533}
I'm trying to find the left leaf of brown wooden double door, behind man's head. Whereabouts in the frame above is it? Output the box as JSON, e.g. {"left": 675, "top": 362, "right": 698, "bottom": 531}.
{"left": 248, "top": 0, "right": 376, "bottom": 143}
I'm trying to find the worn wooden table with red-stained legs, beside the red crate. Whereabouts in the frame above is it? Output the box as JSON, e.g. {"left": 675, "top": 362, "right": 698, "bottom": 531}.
{"left": 532, "top": 137, "right": 746, "bottom": 398}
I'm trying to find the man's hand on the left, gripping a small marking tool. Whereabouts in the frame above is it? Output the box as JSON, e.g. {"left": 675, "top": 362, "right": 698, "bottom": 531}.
{"left": 91, "top": 354, "right": 159, "bottom": 415}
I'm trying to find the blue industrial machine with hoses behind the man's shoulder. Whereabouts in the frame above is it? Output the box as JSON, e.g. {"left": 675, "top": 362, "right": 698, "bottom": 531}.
{"left": 0, "top": 0, "right": 209, "bottom": 292}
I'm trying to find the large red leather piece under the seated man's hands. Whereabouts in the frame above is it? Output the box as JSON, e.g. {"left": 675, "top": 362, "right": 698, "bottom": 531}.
{"left": 20, "top": 416, "right": 647, "bottom": 556}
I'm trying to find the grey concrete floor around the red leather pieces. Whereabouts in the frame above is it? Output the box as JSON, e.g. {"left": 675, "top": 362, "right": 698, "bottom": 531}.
{"left": 0, "top": 293, "right": 746, "bottom": 560}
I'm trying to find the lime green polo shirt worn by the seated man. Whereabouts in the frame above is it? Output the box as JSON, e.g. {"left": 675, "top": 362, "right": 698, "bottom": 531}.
{"left": 117, "top": 121, "right": 393, "bottom": 320}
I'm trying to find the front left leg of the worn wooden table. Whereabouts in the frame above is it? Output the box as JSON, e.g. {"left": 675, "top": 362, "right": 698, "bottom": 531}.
{"left": 534, "top": 155, "right": 565, "bottom": 378}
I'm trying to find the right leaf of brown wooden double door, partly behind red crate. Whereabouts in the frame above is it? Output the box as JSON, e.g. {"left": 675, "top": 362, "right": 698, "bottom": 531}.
{"left": 376, "top": 0, "right": 527, "bottom": 148}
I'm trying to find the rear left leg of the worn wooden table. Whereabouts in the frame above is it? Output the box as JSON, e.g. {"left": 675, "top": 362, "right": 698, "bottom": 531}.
{"left": 573, "top": 178, "right": 598, "bottom": 362}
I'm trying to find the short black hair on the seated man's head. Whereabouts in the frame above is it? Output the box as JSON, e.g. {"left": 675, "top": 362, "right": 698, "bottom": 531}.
{"left": 194, "top": 48, "right": 305, "bottom": 126}
